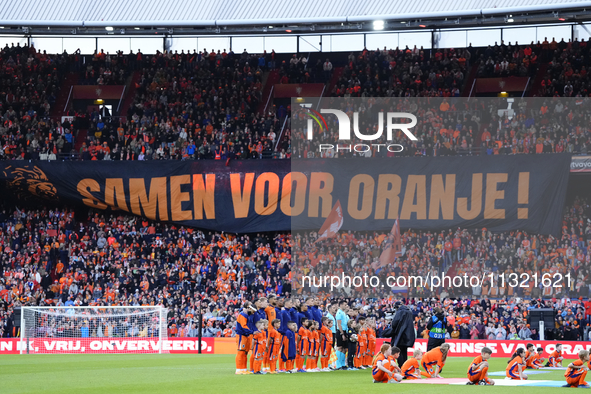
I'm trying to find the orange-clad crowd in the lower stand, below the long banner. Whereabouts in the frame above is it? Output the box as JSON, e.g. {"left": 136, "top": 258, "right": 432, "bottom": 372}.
{"left": 0, "top": 195, "right": 591, "bottom": 339}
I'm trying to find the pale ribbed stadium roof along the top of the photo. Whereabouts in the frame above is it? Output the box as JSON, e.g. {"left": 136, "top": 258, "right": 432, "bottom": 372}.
{"left": 0, "top": 0, "right": 591, "bottom": 27}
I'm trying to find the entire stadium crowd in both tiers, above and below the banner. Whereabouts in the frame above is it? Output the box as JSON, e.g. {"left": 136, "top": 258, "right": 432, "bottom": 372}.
{"left": 0, "top": 42, "right": 591, "bottom": 339}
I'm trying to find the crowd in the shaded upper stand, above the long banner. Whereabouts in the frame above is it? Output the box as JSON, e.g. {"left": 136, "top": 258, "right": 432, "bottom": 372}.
{"left": 0, "top": 40, "right": 589, "bottom": 160}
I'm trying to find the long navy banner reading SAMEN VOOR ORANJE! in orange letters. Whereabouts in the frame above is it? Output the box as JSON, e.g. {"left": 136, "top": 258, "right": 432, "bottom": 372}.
{"left": 0, "top": 154, "right": 571, "bottom": 234}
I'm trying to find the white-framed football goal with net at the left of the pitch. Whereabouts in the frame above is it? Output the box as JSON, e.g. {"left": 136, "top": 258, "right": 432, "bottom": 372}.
{"left": 21, "top": 306, "right": 168, "bottom": 354}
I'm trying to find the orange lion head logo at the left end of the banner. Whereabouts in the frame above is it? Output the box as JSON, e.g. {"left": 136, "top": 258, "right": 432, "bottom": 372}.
{"left": 4, "top": 166, "right": 58, "bottom": 200}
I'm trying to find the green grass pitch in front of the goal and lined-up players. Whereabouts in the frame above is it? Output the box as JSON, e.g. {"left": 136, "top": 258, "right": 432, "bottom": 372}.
{"left": 0, "top": 354, "right": 570, "bottom": 394}
